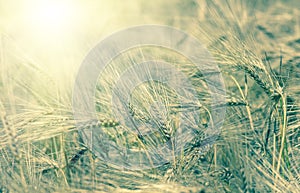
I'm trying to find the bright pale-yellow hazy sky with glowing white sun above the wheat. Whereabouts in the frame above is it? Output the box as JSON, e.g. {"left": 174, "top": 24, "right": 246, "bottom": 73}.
{"left": 0, "top": 0, "right": 198, "bottom": 82}
